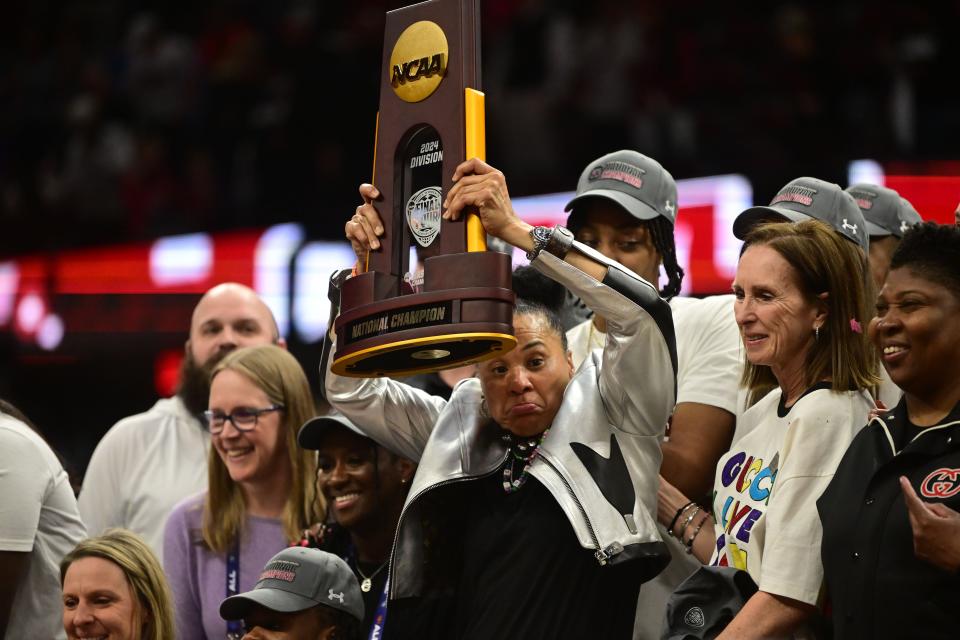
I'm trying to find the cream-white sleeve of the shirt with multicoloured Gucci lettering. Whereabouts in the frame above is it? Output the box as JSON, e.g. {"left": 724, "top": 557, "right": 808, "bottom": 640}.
{"left": 759, "top": 391, "right": 868, "bottom": 605}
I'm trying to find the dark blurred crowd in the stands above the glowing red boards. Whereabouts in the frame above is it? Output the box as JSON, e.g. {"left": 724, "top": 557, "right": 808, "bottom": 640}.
{"left": 0, "top": 0, "right": 960, "bottom": 255}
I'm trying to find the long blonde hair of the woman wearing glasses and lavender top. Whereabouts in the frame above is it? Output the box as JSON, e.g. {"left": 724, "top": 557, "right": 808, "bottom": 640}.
{"left": 201, "top": 345, "right": 323, "bottom": 552}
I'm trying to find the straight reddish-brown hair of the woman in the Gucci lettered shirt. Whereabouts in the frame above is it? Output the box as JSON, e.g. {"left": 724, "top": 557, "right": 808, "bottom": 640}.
{"left": 740, "top": 220, "right": 880, "bottom": 404}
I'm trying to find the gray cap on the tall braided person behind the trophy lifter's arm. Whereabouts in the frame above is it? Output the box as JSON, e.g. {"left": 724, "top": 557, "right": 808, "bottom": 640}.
{"left": 563, "top": 149, "right": 677, "bottom": 223}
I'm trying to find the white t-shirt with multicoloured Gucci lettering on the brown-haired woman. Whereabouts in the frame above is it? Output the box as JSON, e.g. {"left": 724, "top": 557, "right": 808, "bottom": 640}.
{"left": 711, "top": 388, "right": 873, "bottom": 605}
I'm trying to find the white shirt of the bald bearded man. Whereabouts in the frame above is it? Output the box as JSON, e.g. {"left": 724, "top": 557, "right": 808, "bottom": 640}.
{"left": 79, "top": 397, "right": 210, "bottom": 562}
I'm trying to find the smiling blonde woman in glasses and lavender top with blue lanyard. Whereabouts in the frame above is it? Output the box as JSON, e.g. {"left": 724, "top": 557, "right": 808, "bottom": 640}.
{"left": 164, "top": 345, "right": 322, "bottom": 640}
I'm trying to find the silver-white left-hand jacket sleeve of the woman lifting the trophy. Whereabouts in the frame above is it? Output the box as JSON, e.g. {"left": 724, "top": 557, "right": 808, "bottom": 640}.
{"left": 325, "top": 352, "right": 447, "bottom": 462}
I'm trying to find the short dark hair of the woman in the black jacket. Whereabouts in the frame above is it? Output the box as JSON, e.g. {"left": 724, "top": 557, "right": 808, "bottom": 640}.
{"left": 890, "top": 222, "right": 960, "bottom": 298}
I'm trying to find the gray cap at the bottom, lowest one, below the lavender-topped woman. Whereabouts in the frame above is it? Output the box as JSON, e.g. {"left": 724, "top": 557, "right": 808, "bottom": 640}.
{"left": 220, "top": 547, "right": 363, "bottom": 621}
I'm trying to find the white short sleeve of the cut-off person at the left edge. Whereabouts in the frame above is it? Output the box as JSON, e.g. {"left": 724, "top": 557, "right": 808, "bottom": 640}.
{"left": 0, "top": 428, "right": 51, "bottom": 553}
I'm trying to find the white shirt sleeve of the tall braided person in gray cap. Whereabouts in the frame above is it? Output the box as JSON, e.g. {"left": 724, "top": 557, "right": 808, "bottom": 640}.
{"left": 675, "top": 295, "right": 742, "bottom": 415}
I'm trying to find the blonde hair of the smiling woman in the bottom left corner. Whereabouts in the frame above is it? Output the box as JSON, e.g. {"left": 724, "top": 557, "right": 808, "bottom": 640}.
{"left": 60, "top": 529, "right": 175, "bottom": 640}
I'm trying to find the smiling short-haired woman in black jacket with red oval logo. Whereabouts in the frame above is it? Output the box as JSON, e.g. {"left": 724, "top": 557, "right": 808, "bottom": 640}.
{"left": 817, "top": 223, "right": 960, "bottom": 639}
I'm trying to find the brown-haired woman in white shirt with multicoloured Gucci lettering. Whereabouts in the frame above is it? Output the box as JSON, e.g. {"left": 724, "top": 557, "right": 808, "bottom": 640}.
{"left": 660, "top": 220, "right": 879, "bottom": 639}
